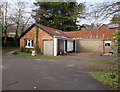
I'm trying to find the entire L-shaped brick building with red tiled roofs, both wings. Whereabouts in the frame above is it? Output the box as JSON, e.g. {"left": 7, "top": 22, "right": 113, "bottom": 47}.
{"left": 20, "top": 24, "right": 116, "bottom": 56}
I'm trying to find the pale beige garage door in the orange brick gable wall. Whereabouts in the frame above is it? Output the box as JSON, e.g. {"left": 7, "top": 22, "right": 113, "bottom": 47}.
{"left": 44, "top": 41, "right": 53, "bottom": 55}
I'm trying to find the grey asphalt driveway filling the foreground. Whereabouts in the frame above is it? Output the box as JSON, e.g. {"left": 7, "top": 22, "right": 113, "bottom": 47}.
{"left": 2, "top": 53, "right": 111, "bottom": 90}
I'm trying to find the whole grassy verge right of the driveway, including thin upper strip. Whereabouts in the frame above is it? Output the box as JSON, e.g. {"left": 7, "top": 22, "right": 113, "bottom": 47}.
{"left": 90, "top": 59, "right": 118, "bottom": 89}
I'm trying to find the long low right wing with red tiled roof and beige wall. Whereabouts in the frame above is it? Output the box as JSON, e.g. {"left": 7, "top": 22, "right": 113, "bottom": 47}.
{"left": 64, "top": 24, "right": 117, "bottom": 54}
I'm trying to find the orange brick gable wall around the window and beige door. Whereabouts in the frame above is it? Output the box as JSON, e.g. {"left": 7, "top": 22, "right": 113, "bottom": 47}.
{"left": 20, "top": 26, "right": 53, "bottom": 54}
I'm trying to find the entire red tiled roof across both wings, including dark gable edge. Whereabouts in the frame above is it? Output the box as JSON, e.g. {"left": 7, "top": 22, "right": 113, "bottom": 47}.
{"left": 19, "top": 24, "right": 116, "bottom": 38}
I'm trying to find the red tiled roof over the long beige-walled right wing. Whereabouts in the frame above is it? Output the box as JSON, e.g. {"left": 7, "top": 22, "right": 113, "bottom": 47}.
{"left": 64, "top": 26, "right": 116, "bottom": 38}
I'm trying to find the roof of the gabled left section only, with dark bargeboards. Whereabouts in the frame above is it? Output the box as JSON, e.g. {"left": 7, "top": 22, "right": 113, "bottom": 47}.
{"left": 19, "top": 23, "right": 70, "bottom": 38}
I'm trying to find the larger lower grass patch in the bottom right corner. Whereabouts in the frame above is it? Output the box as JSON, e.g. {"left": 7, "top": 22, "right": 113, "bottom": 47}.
{"left": 92, "top": 72, "right": 118, "bottom": 89}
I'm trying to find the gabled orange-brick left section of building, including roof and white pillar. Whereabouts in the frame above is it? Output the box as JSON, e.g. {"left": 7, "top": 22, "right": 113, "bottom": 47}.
{"left": 20, "top": 24, "right": 76, "bottom": 56}
